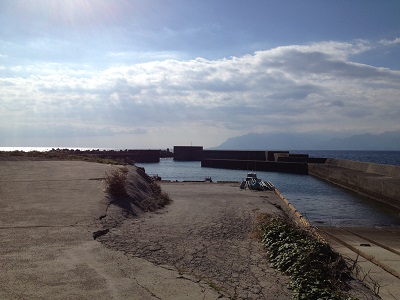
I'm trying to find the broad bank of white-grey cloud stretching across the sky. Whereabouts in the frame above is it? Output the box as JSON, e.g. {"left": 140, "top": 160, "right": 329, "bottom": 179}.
{"left": 0, "top": 41, "right": 400, "bottom": 145}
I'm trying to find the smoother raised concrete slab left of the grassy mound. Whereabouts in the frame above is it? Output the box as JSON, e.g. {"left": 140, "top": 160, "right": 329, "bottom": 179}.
{"left": 0, "top": 161, "right": 233, "bottom": 300}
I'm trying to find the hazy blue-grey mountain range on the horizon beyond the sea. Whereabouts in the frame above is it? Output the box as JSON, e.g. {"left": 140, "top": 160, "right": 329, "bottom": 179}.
{"left": 213, "top": 130, "right": 400, "bottom": 151}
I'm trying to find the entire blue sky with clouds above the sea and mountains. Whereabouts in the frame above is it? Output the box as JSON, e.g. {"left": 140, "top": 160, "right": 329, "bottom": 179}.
{"left": 0, "top": 0, "right": 400, "bottom": 149}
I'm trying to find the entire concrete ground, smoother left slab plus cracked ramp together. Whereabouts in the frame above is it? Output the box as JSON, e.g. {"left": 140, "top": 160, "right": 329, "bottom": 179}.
{"left": 0, "top": 161, "right": 290, "bottom": 299}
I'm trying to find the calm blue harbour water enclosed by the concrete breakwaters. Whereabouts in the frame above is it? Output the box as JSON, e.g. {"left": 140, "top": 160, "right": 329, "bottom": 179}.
{"left": 137, "top": 159, "right": 400, "bottom": 226}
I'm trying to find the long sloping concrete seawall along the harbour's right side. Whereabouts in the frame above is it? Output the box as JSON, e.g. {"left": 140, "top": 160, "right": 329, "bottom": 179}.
{"left": 308, "top": 158, "right": 400, "bottom": 209}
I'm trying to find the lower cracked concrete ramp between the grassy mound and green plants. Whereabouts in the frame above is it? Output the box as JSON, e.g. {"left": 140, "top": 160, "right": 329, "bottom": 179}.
{"left": 99, "top": 183, "right": 291, "bottom": 299}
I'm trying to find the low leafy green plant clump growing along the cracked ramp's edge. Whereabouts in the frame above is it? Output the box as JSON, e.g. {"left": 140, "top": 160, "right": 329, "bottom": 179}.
{"left": 261, "top": 216, "right": 351, "bottom": 300}
